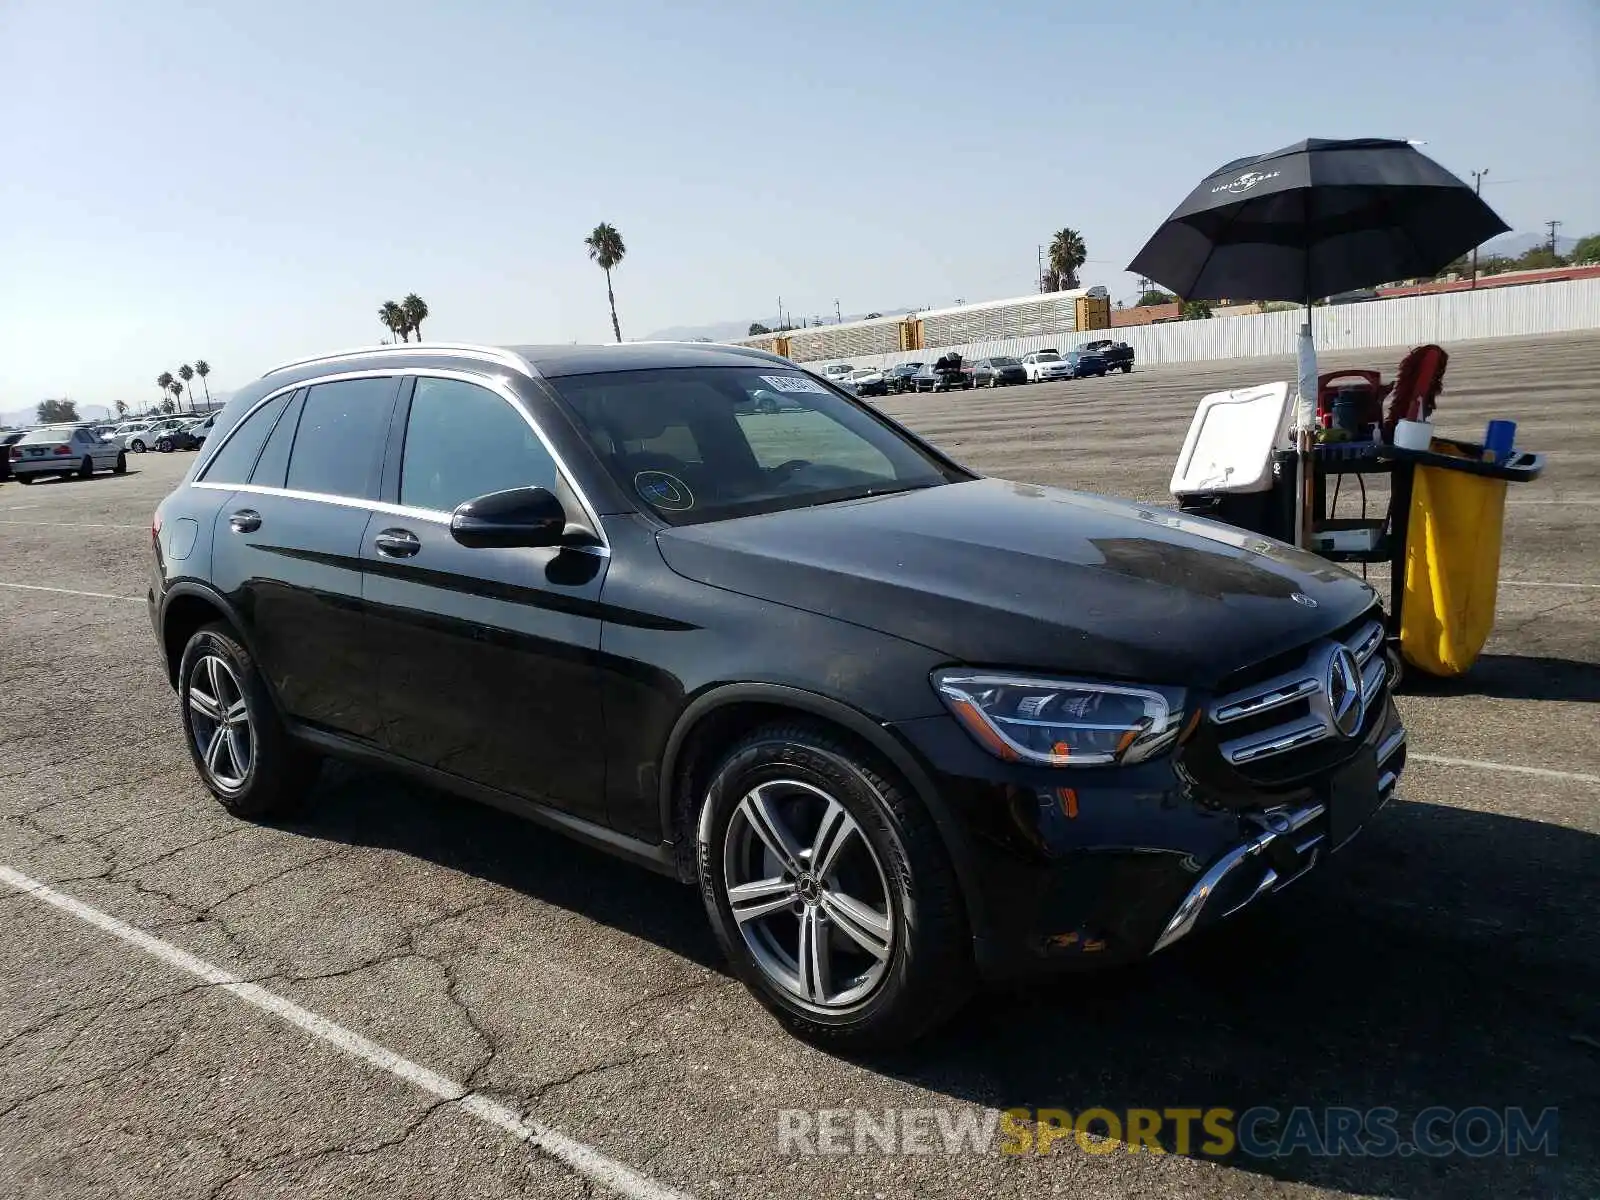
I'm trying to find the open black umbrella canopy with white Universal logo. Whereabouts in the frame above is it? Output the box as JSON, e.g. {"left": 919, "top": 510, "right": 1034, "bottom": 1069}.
{"left": 1128, "top": 138, "right": 1509, "bottom": 304}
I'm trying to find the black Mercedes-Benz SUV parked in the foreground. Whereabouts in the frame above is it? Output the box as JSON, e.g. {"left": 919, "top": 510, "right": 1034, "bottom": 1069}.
{"left": 149, "top": 344, "right": 1405, "bottom": 1046}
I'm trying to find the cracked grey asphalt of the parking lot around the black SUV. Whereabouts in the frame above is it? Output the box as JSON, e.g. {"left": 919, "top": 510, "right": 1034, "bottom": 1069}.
{"left": 0, "top": 336, "right": 1600, "bottom": 1198}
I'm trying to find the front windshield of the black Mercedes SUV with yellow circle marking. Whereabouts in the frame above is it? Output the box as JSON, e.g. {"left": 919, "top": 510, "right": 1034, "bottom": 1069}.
{"left": 550, "top": 365, "right": 966, "bottom": 525}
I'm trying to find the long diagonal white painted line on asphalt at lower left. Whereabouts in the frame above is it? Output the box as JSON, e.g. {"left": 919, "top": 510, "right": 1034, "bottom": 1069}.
{"left": 0, "top": 866, "right": 688, "bottom": 1200}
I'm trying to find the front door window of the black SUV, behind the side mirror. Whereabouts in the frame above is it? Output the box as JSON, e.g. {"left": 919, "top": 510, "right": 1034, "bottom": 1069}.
{"left": 400, "top": 378, "right": 557, "bottom": 512}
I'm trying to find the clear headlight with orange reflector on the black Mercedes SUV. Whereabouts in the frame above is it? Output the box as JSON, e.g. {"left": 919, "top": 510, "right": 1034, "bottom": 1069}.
{"left": 933, "top": 669, "right": 1184, "bottom": 766}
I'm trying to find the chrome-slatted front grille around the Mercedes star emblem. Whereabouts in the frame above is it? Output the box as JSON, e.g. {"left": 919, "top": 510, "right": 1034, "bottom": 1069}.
{"left": 1208, "top": 618, "right": 1389, "bottom": 774}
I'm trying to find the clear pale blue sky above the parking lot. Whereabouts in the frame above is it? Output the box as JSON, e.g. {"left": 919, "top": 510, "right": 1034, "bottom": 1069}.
{"left": 0, "top": 0, "right": 1600, "bottom": 411}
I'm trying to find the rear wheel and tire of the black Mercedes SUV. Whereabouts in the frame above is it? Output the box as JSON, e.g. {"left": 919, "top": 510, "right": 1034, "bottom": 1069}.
{"left": 178, "top": 622, "right": 318, "bottom": 821}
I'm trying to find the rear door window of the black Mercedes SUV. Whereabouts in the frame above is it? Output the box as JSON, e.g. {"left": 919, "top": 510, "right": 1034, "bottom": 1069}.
{"left": 286, "top": 378, "right": 397, "bottom": 499}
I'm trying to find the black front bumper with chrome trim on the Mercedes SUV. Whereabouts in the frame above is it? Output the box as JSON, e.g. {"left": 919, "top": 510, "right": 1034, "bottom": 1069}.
{"left": 891, "top": 698, "right": 1406, "bottom": 979}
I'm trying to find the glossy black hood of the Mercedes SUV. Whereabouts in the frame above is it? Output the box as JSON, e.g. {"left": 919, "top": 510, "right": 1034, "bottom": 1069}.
{"left": 658, "top": 480, "right": 1374, "bottom": 686}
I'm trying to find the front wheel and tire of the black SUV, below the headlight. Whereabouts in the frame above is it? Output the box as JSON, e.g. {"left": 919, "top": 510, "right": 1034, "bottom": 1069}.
{"left": 698, "top": 723, "right": 973, "bottom": 1051}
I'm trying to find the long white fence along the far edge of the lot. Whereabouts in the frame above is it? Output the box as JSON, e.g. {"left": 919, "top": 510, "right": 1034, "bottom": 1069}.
{"left": 806, "top": 280, "right": 1600, "bottom": 371}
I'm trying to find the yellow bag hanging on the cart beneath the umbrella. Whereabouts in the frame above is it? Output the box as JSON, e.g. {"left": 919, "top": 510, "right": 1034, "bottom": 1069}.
{"left": 1400, "top": 466, "right": 1506, "bottom": 675}
